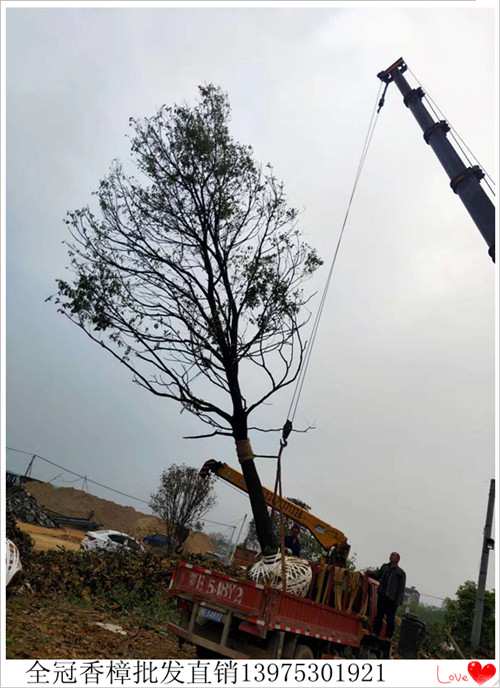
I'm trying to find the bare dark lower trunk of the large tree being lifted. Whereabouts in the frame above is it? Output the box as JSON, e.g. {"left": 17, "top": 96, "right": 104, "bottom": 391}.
{"left": 233, "top": 419, "right": 278, "bottom": 554}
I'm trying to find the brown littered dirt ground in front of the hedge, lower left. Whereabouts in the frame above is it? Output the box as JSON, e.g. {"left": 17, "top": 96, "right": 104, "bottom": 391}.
{"left": 6, "top": 593, "right": 195, "bottom": 659}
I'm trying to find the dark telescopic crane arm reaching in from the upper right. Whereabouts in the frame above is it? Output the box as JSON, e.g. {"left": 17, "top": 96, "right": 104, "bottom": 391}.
{"left": 377, "top": 57, "right": 495, "bottom": 262}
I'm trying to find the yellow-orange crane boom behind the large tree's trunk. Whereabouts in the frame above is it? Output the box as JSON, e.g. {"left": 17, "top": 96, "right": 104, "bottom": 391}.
{"left": 200, "top": 459, "right": 347, "bottom": 550}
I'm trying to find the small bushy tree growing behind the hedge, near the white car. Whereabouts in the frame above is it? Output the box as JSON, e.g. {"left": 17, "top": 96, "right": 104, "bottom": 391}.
{"left": 149, "top": 464, "right": 216, "bottom": 551}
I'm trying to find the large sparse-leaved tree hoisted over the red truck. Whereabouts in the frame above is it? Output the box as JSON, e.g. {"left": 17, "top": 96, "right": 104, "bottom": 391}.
{"left": 56, "top": 85, "right": 321, "bottom": 551}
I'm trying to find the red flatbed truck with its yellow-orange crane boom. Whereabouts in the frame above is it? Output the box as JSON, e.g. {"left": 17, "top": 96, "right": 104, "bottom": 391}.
{"left": 169, "top": 460, "right": 390, "bottom": 659}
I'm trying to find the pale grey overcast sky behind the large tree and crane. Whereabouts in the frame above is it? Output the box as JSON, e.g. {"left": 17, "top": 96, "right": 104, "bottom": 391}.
{"left": 7, "top": 6, "right": 496, "bottom": 603}
